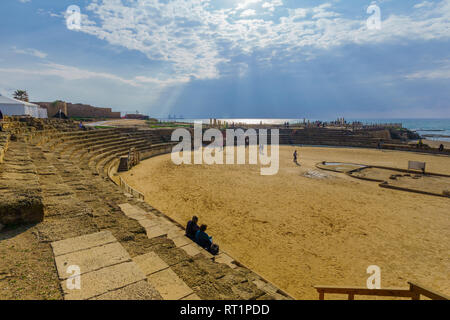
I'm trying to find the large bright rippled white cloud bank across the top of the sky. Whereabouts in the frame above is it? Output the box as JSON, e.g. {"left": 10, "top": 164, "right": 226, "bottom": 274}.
{"left": 70, "top": 0, "right": 450, "bottom": 79}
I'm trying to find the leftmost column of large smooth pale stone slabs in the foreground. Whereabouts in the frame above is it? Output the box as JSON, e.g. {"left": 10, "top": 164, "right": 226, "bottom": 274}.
{"left": 51, "top": 231, "right": 161, "bottom": 300}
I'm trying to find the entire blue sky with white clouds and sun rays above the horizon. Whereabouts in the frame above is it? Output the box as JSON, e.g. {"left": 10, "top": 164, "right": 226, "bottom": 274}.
{"left": 0, "top": 0, "right": 450, "bottom": 119}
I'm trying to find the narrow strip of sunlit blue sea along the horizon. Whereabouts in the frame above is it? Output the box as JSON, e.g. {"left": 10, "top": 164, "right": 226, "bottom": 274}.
{"left": 158, "top": 118, "right": 450, "bottom": 142}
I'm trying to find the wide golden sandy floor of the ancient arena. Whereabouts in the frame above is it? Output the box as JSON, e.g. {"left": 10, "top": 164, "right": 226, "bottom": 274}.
{"left": 118, "top": 146, "right": 450, "bottom": 299}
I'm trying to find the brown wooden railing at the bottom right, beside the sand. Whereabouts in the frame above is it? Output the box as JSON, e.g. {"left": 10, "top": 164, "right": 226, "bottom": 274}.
{"left": 314, "top": 282, "right": 450, "bottom": 300}
